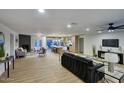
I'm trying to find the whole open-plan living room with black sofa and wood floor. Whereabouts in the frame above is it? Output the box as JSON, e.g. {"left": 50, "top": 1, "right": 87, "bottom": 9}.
{"left": 0, "top": 9, "right": 124, "bottom": 83}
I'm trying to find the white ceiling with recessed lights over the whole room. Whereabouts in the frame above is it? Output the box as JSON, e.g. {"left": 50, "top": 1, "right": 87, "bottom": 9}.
{"left": 0, "top": 9, "right": 124, "bottom": 35}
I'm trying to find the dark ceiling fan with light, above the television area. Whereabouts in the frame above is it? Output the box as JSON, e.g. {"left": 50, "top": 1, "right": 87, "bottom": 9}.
{"left": 97, "top": 23, "right": 124, "bottom": 32}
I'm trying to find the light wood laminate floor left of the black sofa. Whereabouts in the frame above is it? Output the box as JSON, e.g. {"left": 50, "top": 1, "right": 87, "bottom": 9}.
{"left": 0, "top": 53, "right": 83, "bottom": 83}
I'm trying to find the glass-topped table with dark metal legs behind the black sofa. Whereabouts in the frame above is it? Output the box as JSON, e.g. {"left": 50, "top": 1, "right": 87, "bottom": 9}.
{"left": 97, "top": 66, "right": 124, "bottom": 83}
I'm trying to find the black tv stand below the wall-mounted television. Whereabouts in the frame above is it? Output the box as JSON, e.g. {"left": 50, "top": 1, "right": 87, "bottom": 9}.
{"left": 98, "top": 50, "right": 124, "bottom": 64}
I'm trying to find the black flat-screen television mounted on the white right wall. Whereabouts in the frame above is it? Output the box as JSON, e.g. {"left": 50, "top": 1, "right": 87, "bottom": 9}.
{"left": 102, "top": 39, "right": 119, "bottom": 47}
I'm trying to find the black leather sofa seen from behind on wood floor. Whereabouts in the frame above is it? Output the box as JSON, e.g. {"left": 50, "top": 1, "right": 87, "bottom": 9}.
{"left": 61, "top": 53, "right": 104, "bottom": 83}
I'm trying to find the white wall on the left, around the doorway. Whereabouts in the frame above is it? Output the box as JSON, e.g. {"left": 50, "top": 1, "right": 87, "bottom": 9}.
{"left": 0, "top": 23, "right": 17, "bottom": 75}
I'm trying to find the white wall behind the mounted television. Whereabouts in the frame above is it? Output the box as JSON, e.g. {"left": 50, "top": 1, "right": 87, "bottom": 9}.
{"left": 80, "top": 31, "right": 124, "bottom": 55}
